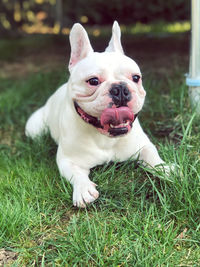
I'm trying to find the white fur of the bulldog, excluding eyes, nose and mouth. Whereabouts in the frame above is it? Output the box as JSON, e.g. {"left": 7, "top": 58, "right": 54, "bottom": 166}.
{"left": 25, "top": 22, "right": 166, "bottom": 207}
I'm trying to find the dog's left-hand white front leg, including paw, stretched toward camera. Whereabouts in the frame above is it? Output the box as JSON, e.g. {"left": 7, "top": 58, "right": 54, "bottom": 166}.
{"left": 57, "top": 147, "right": 99, "bottom": 208}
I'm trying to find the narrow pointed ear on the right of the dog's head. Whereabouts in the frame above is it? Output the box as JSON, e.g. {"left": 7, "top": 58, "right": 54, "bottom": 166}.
{"left": 105, "top": 21, "right": 124, "bottom": 54}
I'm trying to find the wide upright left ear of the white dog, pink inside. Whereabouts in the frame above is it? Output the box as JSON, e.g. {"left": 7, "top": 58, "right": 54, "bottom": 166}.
{"left": 69, "top": 23, "right": 93, "bottom": 71}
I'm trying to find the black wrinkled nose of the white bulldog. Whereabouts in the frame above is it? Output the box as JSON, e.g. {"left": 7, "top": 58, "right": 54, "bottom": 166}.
{"left": 110, "top": 82, "right": 131, "bottom": 107}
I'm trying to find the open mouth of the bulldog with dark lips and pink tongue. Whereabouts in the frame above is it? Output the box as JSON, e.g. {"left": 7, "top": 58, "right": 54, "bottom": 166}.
{"left": 74, "top": 102, "right": 137, "bottom": 136}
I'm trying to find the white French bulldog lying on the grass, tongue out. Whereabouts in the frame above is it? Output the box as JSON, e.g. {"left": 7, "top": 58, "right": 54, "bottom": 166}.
{"left": 25, "top": 21, "right": 168, "bottom": 207}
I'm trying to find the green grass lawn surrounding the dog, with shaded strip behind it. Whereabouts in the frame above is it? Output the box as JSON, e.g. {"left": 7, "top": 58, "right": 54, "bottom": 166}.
{"left": 0, "top": 33, "right": 200, "bottom": 267}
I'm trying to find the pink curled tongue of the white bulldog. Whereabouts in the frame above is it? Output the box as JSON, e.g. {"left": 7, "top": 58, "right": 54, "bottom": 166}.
{"left": 100, "top": 107, "right": 134, "bottom": 126}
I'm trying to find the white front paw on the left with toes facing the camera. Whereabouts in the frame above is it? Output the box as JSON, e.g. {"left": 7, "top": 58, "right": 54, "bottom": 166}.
{"left": 73, "top": 180, "right": 99, "bottom": 208}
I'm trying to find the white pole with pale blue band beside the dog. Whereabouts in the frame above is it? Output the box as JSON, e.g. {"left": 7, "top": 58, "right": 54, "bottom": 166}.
{"left": 186, "top": 0, "right": 200, "bottom": 115}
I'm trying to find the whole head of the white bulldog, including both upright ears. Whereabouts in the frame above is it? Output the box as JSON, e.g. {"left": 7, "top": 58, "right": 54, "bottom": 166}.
{"left": 69, "top": 22, "right": 146, "bottom": 137}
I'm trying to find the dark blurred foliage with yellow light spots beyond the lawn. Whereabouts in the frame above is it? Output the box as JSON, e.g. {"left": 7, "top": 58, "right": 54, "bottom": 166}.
{"left": 0, "top": 0, "right": 190, "bottom": 35}
